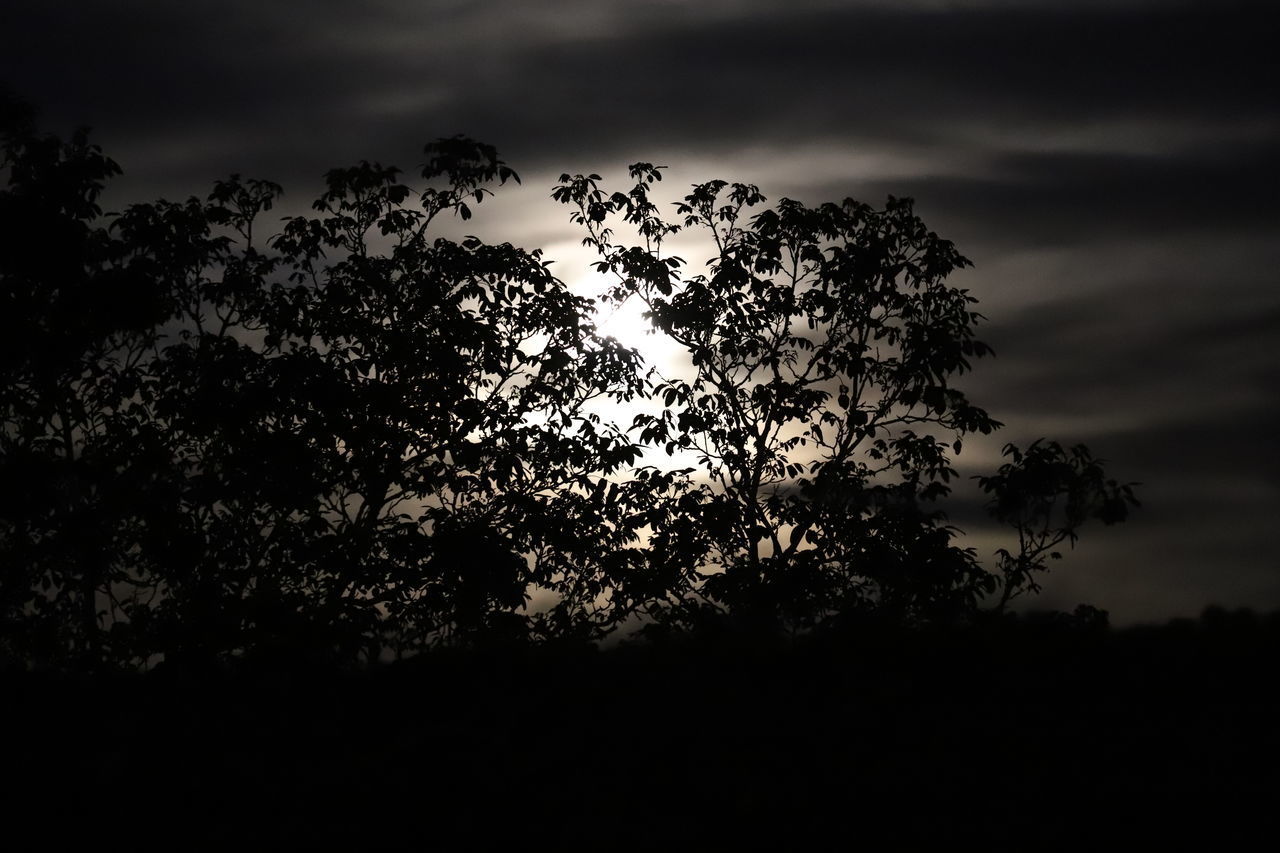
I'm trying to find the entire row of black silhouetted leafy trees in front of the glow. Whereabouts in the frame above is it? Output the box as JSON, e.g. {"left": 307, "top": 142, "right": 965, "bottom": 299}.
{"left": 0, "top": 109, "right": 1133, "bottom": 666}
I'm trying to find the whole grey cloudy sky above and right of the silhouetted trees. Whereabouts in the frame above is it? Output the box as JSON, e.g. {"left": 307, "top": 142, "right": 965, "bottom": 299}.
{"left": 0, "top": 0, "right": 1280, "bottom": 624}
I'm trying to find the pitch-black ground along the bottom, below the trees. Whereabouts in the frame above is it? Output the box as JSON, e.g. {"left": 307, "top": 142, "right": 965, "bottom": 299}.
{"left": 3, "top": 604, "right": 1280, "bottom": 850}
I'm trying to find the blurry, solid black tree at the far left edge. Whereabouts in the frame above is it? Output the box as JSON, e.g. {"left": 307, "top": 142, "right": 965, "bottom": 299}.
{"left": 0, "top": 100, "right": 147, "bottom": 660}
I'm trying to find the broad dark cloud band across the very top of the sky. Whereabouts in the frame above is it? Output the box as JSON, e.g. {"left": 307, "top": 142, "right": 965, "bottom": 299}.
{"left": 3, "top": 1, "right": 1276, "bottom": 189}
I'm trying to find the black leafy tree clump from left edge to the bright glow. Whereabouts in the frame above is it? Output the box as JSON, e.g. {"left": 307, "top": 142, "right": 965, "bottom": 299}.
{"left": 0, "top": 111, "right": 653, "bottom": 660}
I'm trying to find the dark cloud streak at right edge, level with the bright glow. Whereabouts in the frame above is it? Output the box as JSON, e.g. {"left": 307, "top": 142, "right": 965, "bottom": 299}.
{"left": 980, "top": 279, "right": 1280, "bottom": 421}
